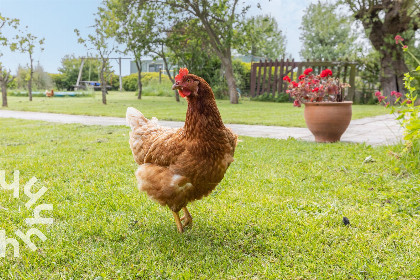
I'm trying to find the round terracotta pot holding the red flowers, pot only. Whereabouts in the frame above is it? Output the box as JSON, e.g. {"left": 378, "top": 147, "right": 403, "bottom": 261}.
{"left": 304, "top": 101, "right": 353, "bottom": 142}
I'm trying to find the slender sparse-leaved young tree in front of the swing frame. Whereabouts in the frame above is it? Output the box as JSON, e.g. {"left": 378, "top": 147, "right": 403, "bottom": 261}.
{"left": 74, "top": 13, "right": 115, "bottom": 105}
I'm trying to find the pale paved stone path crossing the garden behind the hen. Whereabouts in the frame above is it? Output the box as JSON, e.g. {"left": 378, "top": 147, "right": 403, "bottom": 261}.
{"left": 0, "top": 110, "right": 402, "bottom": 146}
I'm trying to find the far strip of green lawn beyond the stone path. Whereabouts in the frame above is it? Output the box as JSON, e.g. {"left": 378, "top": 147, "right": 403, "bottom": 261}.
{"left": 1, "top": 92, "right": 389, "bottom": 127}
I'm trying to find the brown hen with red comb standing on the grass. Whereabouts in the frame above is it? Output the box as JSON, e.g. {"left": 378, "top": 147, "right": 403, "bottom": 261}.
{"left": 127, "top": 68, "right": 237, "bottom": 232}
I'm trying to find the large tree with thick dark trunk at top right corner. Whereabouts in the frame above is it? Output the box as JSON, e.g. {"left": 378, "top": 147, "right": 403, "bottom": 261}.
{"left": 344, "top": 0, "right": 420, "bottom": 95}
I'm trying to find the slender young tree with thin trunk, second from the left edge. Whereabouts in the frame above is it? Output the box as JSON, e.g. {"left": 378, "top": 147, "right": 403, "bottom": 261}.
{"left": 11, "top": 32, "right": 45, "bottom": 101}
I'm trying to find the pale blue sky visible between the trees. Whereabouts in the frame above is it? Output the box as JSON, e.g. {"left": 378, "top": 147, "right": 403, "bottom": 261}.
{"left": 0, "top": 0, "right": 316, "bottom": 75}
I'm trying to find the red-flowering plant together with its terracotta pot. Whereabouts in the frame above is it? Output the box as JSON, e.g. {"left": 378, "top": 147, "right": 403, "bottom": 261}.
{"left": 283, "top": 68, "right": 353, "bottom": 142}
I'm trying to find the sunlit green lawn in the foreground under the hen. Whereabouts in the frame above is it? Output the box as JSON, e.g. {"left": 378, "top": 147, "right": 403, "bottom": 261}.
{"left": 0, "top": 118, "right": 420, "bottom": 279}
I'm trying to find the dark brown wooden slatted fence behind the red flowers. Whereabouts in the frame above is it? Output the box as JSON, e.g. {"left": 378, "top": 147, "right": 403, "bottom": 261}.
{"left": 250, "top": 59, "right": 356, "bottom": 100}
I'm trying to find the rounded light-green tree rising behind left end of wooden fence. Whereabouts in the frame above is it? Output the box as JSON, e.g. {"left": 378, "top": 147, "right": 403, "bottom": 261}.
{"left": 237, "top": 15, "right": 286, "bottom": 60}
